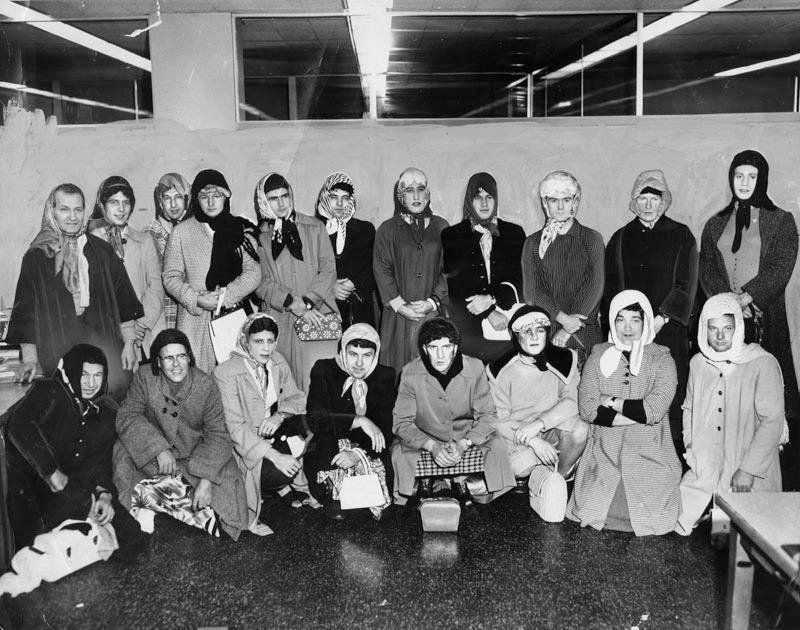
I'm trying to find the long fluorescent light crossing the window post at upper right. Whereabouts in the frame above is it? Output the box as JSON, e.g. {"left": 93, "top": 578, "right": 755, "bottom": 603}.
{"left": 544, "top": 0, "right": 738, "bottom": 81}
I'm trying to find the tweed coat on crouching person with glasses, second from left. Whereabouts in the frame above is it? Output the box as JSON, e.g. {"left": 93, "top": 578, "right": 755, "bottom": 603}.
{"left": 114, "top": 367, "right": 248, "bottom": 540}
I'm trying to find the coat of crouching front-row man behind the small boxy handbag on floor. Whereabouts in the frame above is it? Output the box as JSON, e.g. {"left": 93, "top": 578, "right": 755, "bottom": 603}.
{"left": 392, "top": 356, "right": 516, "bottom": 496}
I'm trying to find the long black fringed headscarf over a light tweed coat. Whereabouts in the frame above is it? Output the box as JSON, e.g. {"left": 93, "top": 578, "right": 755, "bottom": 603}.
{"left": 189, "top": 169, "right": 259, "bottom": 291}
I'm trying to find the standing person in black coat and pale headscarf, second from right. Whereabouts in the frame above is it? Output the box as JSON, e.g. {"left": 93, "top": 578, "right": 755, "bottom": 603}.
{"left": 603, "top": 170, "right": 698, "bottom": 462}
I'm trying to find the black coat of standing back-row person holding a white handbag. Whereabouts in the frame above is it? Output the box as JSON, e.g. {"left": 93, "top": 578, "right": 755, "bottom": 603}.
{"left": 442, "top": 219, "right": 525, "bottom": 362}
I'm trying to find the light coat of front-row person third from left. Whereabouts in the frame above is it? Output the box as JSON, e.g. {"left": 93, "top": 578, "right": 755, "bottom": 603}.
{"left": 214, "top": 352, "right": 306, "bottom": 524}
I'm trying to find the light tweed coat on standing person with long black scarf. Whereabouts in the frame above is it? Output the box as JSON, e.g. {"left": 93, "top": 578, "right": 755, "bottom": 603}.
{"left": 161, "top": 217, "right": 261, "bottom": 374}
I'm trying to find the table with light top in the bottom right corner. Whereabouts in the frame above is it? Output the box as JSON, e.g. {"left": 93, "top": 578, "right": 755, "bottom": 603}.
{"left": 716, "top": 492, "right": 800, "bottom": 630}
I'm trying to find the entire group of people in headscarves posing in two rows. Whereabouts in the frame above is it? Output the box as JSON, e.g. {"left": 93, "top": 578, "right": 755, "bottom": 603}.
{"left": 4, "top": 151, "right": 800, "bottom": 548}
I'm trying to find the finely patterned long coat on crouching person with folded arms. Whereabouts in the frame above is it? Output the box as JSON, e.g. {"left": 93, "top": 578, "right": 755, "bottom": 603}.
{"left": 567, "top": 343, "right": 681, "bottom": 536}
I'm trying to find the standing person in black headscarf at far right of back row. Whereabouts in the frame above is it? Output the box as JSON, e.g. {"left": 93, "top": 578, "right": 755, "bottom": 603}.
{"left": 700, "top": 150, "right": 800, "bottom": 438}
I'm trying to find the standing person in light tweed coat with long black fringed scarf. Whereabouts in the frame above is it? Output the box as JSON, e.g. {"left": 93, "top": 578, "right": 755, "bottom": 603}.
{"left": 161, "top": 169, "right": 261, "bottom": 374}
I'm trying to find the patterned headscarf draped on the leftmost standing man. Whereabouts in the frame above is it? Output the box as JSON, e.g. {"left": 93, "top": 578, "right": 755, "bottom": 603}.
{"left": 30, "top": 184, "right": 90, "bottom": 316}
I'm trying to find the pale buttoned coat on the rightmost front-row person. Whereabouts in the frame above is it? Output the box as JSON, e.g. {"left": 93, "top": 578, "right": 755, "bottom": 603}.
{"left": 677, "top": 354, "right": 784, "bottom": 535}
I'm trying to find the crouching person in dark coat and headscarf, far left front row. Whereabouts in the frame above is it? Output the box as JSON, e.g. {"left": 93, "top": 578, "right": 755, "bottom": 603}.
{"left": 0, "top": 344, "right": 147, "bottom": 553}
